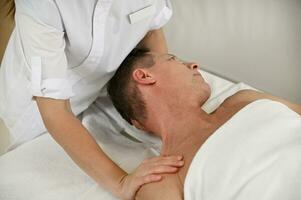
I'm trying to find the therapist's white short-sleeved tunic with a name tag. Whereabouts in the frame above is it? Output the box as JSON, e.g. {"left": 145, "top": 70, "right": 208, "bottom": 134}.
{"left": 0, "top": 0, "right": 172, "bottom": 148}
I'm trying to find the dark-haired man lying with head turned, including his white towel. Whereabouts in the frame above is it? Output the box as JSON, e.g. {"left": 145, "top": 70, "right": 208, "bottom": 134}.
{"left": 108, "top": 49, "right": 301, "bottom": 200}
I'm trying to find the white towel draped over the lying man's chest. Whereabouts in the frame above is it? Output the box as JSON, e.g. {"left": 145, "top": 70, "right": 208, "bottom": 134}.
{"left": 184, "top": 100, "right": 301, "bottom": 200}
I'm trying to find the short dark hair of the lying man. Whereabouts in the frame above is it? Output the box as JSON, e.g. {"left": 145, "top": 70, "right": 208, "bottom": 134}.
{"left": 107, "top": 48, "right": 155, "bottom": 124}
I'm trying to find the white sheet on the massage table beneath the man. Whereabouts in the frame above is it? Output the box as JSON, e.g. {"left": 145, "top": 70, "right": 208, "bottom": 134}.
{"left": 0, "top": 72, "right": 249, "bottom": 200}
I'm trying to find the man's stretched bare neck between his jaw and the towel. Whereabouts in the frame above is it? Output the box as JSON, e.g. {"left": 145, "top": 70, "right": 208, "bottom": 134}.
{"left": 156, "top": 108, "right": 217, "bottom": 155}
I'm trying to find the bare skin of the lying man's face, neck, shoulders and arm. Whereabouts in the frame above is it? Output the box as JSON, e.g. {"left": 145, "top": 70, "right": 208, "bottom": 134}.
{"left": 132, "top": 53, "right": 301, "bottom": 200}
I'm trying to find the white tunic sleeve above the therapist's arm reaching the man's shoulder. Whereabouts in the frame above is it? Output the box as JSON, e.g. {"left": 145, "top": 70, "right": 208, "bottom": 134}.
{"left": 15, "top": 0, "right": 73, "bottom": 99}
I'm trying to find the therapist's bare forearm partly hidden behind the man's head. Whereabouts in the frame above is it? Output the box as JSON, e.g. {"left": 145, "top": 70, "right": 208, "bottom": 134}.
{"left": 137, "top": 29, "right": 168, "bottom": 53}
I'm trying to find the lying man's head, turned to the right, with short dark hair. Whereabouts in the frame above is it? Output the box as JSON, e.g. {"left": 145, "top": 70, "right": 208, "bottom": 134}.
{"left": 108, "top": 49, "right": 211, "bottom": 131}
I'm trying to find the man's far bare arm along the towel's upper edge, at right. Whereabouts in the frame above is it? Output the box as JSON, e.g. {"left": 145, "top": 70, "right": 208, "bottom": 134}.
{"left": 235, "top": 90, "right": 301, "bottom": 115}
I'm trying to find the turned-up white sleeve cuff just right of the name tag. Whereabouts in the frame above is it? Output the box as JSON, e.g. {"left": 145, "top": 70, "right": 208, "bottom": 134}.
{"left": 150, "top": 0, "right": 172, "bottom": 30}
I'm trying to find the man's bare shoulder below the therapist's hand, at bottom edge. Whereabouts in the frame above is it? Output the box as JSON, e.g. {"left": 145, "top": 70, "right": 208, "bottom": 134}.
{"left": 136, "top": 174, "right": 184, "bottom": 200}
